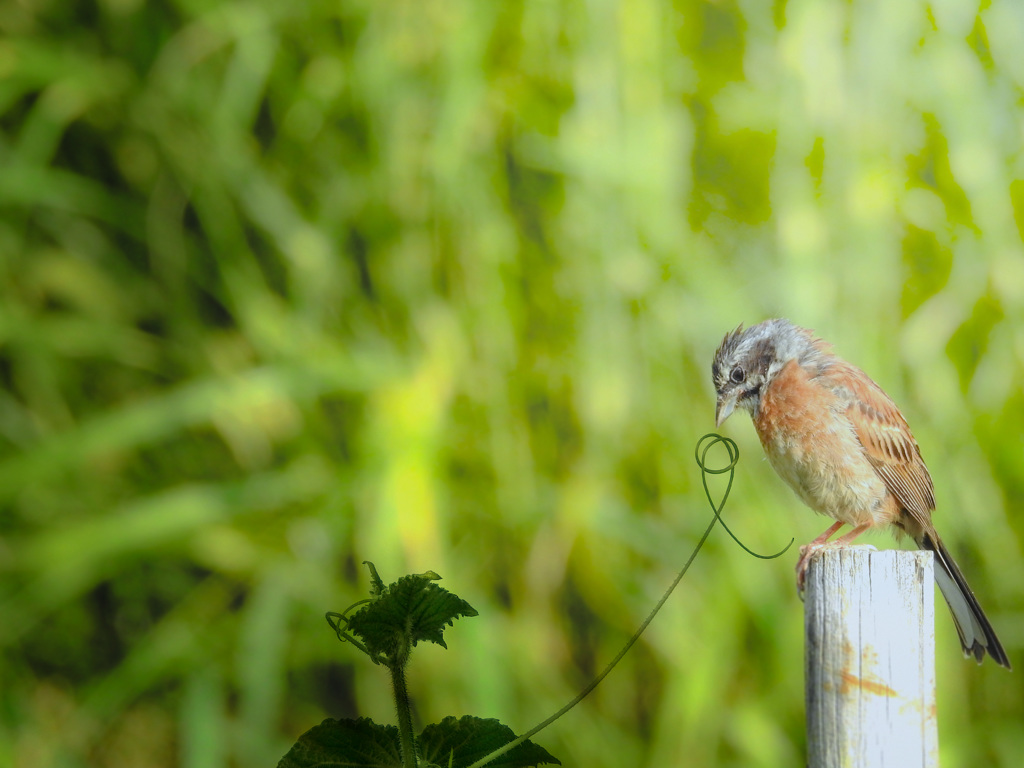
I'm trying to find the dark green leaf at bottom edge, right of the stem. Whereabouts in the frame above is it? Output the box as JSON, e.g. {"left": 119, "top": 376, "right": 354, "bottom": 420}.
{"left": 419, "top": 715, "right": 561, "bottom": 768}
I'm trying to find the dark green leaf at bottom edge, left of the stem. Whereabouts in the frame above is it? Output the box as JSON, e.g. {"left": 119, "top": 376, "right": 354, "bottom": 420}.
{"left": 278, "top": 718, "right": 401, "bottom": 768}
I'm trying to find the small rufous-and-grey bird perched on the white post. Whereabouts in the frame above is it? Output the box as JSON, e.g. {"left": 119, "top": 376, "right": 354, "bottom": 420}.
{"left": 712, "top": 318, "right": 1011, "bottom": 669}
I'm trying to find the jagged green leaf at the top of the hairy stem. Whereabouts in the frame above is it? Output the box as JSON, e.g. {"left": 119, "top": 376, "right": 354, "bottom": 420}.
{"left": 348, "top": 572, "right": 477, "bottom": 663}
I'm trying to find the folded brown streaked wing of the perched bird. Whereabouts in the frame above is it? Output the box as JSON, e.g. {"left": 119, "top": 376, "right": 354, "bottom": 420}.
{"left": 843, "top": 364, "right": 935, "bottom": 529}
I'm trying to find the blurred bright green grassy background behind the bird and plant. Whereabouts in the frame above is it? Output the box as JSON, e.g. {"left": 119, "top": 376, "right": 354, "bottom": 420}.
{"left": 0, "top": 0, "right": 1024, "bottom": 768}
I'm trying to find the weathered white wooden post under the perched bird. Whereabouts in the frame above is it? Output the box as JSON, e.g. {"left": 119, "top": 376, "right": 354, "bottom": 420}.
{"left": 804, "top": 547, "right": 939, "bottom": 768}
